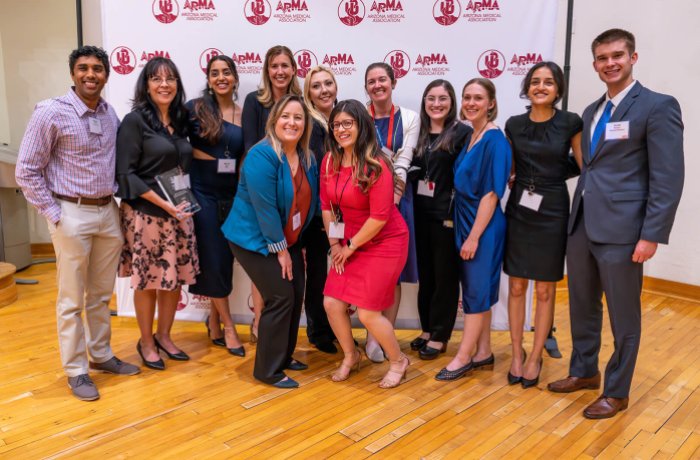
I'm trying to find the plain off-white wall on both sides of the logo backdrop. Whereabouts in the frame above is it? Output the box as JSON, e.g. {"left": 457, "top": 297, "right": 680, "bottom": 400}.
{"left": 0, "top": 0, "right": 700, "bottom": 285}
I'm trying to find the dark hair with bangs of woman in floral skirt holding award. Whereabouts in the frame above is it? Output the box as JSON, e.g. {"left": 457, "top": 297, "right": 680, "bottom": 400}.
{"left": 131, "top": 57, "right": 187, "bottom": 137}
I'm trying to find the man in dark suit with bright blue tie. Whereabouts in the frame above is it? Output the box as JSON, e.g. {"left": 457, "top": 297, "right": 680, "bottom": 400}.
{"left": 547, "top": 29, "right": 683, "bottom": 419}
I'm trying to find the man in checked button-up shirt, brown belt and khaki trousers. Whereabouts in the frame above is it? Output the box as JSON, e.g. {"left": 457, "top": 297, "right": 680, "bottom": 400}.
{"left": 15, "top": 46, "right": 139, "bottom": 401}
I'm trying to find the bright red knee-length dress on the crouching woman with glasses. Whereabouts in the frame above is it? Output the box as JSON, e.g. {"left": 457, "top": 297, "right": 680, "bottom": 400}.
{"left": 320, "top": 154, "right": 408, "bottom": 310}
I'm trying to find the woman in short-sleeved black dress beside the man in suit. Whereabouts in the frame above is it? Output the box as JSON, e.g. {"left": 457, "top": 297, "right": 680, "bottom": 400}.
{"left": 503, "top": 62, "right": 583, "bottom": 388}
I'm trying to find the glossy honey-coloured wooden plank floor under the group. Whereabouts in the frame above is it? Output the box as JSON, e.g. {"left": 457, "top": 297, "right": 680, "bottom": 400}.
{"left": 0, "top": 264, "right": 700, "bottom": 459}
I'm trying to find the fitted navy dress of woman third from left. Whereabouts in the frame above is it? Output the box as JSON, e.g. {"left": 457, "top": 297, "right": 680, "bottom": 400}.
{"left": 187, "top": 101, "right": 243, "bottom": 298}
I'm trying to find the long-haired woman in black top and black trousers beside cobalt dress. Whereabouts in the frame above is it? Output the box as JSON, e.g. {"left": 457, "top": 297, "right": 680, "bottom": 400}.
{"left": 408, "top": 80, "right": 472, "bottom": 359}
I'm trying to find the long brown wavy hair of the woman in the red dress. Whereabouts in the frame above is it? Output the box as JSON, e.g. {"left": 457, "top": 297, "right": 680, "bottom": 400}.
{"left": 328, "top": 99, "right": 393, "bottom": 193}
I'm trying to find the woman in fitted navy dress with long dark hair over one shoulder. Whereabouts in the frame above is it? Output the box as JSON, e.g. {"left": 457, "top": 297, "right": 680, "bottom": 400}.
{"left": 187, "top": 55, "right": 245, "bottom": 356}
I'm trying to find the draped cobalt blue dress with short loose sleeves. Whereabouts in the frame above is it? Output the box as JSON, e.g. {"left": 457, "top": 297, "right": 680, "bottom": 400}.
{"left": 455, "top": 129, "right": 511, "bottom": 313}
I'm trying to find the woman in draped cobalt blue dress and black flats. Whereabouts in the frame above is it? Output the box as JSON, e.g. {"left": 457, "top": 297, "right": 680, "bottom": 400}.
{"left": 435, "top": 78, "right": 512, "bottom": 380}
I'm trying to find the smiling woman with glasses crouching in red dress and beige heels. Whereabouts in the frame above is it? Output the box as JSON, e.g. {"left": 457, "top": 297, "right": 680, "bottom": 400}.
{"left": 320, "top": 100, "right": 409, "bottom": 388}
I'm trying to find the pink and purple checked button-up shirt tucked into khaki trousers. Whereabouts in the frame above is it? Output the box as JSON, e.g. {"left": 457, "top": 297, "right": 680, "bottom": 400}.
{"left": 15, "top": 89, "right": 119, "bottom": 224}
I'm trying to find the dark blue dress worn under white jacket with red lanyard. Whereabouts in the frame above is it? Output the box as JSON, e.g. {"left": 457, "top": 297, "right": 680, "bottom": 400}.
{"left": 374, "top": 109, "right": 418, "bottom": 283}
